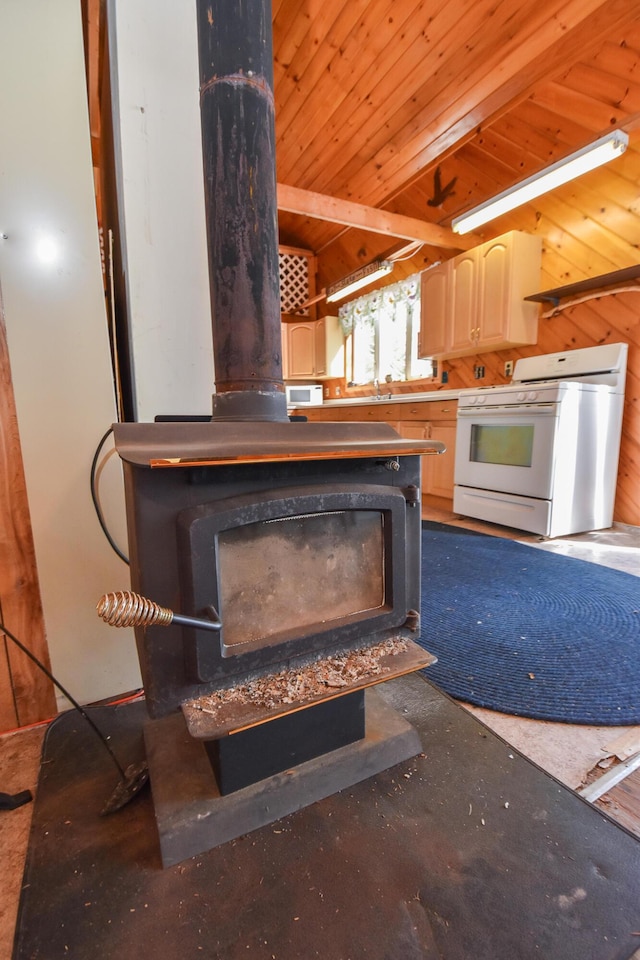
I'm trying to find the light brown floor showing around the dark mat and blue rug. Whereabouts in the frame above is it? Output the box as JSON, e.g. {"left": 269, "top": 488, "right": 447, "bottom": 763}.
{"left": 0, "top": 508, "right": 640, "bottom": 960}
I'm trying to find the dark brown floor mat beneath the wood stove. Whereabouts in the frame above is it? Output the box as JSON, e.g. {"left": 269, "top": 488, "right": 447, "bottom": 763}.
{"left": 13, "top": 675, "right": 640, "bottom": 960}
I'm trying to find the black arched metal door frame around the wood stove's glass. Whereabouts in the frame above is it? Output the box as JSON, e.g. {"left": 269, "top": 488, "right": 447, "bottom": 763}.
{"left": 177, "top": 484, "right": 410, "bottom": 683}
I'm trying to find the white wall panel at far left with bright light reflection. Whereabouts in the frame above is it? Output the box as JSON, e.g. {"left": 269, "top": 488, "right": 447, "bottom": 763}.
{"left": 0, "top": 0, "right": 141, "bottom": 702}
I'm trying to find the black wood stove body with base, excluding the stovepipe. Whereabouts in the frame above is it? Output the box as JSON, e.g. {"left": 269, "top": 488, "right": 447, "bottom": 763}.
{"left": 114, "top": 421, "right": 442, "bottom": 865}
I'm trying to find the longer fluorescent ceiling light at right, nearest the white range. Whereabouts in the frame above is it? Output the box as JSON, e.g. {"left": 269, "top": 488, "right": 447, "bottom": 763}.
{"left": 451, "top": 130, "right": 629, "bottom": 233}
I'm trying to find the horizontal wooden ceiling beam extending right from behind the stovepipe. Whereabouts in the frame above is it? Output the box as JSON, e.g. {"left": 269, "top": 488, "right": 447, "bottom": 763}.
{"left": 278, "top": 183, "right": 478, "bottom": 250}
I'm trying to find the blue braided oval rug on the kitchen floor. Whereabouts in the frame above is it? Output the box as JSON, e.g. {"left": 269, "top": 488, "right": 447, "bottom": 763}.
{"left": 419, "top": 521, "right": 640, "bottom": 726}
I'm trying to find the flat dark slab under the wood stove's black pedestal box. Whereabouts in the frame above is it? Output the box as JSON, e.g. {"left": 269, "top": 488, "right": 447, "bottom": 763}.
{"left": 144, "top": 690, "right": 422, "bottom": 867}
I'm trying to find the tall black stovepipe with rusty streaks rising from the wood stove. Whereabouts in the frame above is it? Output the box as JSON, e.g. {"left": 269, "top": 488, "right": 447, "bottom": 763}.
{"left": 196, "top": 0, "right": 287, "bottom": 420}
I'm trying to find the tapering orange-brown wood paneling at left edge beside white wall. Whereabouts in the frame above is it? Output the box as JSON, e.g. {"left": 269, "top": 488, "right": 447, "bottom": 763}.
{"left": 0, "top": 301, "right": 56, "bottom": 730}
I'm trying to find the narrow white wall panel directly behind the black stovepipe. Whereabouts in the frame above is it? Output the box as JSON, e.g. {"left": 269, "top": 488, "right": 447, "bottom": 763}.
{"left": 107, "top": 0, "right": 214, "bottom": 420}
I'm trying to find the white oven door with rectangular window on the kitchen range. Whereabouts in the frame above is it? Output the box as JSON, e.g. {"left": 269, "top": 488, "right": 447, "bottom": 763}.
{"left": 455, "top": 403, "right": 559, "bottom": 500}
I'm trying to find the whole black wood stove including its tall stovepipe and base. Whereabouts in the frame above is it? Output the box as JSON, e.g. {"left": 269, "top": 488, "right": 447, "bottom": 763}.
{"left": 101, "top": 0, "right": 444, "bottom": 865}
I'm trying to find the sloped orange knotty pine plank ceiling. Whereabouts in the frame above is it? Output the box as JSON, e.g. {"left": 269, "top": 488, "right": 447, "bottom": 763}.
{"left": 273, "top": 0, "right": 640, "bottom": 282}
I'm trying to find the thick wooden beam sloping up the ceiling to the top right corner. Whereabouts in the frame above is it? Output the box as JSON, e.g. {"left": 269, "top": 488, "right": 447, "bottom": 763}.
{"left": 354, "top": 0, "right": 638, "bottom": 205}
